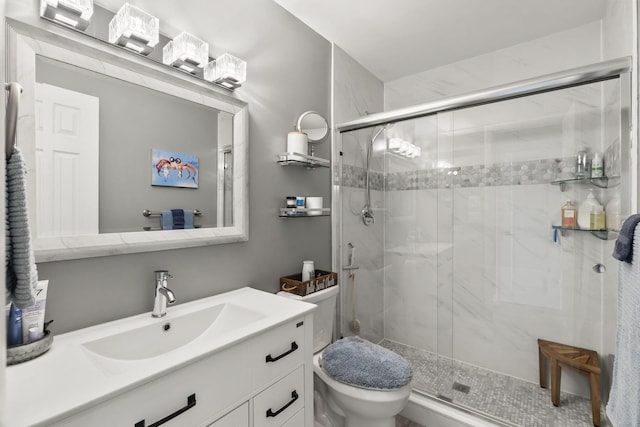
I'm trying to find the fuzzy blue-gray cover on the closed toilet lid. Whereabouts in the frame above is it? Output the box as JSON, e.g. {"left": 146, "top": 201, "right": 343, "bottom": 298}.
{"left": 322, "top": 337, "right": 412, "bottom": 389}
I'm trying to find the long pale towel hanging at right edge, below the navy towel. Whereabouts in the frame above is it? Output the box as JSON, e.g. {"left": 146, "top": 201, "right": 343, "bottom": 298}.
{"left": 607, "top": 222, "right": 640, "bottom": 427}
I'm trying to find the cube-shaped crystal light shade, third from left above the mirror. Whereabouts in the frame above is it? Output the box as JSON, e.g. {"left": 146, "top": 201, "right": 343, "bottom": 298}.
{"left": 162, "top": 32, "right": 209, "bottom": 74}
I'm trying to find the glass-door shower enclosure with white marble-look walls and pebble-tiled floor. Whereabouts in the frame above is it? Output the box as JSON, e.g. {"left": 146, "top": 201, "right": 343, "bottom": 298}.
{"left": 333, "top": 58, "right": 635, "bottom": 426}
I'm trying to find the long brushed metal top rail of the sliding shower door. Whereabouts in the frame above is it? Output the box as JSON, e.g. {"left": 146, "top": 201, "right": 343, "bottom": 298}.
{"left": 336, "top": 56, "right": 631, "bottom": 133}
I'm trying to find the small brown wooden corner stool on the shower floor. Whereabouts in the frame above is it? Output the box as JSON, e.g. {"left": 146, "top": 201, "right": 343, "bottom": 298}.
{"left": 538, "top": 339, "right": 600, "bottom": 426}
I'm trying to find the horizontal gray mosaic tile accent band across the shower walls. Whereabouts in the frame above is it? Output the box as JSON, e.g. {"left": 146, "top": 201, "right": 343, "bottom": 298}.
{"left": 342, "top": 157, "right": 575, "bottom": 191}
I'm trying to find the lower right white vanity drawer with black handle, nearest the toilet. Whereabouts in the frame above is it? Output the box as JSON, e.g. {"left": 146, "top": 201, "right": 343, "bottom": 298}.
{"left": 253, "top": 366, "right": 305, "bottom": 427}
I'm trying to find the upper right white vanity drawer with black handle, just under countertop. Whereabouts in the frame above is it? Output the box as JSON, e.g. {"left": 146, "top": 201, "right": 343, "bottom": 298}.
{"left": 252, "top": 318, "right": 305, "bottom": 389}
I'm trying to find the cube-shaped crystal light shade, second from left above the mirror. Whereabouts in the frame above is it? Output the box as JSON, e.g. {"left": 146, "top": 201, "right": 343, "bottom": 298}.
{"left": 109, "top": 3, "right": 160, "bottom": 55}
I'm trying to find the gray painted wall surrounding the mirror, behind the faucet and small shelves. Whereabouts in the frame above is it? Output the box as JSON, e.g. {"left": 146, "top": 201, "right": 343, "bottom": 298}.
{"left": 7, "top": 0, "right": 331, "bottom": 334}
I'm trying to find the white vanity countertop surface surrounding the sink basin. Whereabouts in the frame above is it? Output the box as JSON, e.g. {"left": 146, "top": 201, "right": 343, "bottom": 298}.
{"left": 6, "top": 287, "right": 315, "bottom": 426}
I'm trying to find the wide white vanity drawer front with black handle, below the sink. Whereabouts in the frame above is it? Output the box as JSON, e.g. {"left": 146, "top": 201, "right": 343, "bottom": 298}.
{"left": 54, "top": 343, "right": 251, "bottom": 427}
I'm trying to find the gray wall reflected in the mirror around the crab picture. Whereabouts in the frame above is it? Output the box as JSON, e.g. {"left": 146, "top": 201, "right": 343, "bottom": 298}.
{"left": 36, "top": 57, "right": 218, "bottom": 233}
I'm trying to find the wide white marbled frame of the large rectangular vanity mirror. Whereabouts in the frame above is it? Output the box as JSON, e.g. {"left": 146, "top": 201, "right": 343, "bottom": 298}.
{"left": 6, "top": 18, "right": 249, "bottom": 262}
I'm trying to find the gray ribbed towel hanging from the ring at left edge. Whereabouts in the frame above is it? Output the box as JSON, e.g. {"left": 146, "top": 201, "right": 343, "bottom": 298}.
{"left": 5, "top": 148, "right": 38, "bottom": 308}
